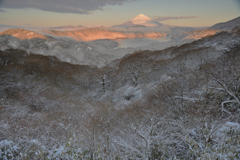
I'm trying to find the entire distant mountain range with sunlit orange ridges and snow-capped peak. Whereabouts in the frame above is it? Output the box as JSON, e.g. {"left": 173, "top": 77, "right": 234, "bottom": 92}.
{"left": 0, "top": 14, "right": 240, "bottom": 41}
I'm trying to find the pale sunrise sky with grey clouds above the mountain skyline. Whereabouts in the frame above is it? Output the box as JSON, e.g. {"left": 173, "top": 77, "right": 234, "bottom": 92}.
{"left": 0, "top": 0, "right": 240, "bottom": 27}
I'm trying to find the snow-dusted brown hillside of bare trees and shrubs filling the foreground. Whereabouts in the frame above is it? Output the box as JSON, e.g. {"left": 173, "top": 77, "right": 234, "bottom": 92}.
{"left": 0, "top": 29, "right": 240, "bottom": 160}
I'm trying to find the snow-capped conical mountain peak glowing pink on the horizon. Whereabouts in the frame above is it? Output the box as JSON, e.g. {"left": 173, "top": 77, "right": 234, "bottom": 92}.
{"left": 113, "top": 14, "right": 163, "bottom": 27}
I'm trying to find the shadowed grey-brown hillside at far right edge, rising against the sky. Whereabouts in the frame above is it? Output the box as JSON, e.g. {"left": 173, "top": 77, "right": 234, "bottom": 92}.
{"left": 209, "top": 17, "right": 240, "bottom": 31}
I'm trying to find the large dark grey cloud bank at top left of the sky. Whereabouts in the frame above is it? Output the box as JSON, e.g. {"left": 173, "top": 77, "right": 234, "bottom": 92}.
{"left": 0, "top": 0, "right": 134, "bottom": 14}
